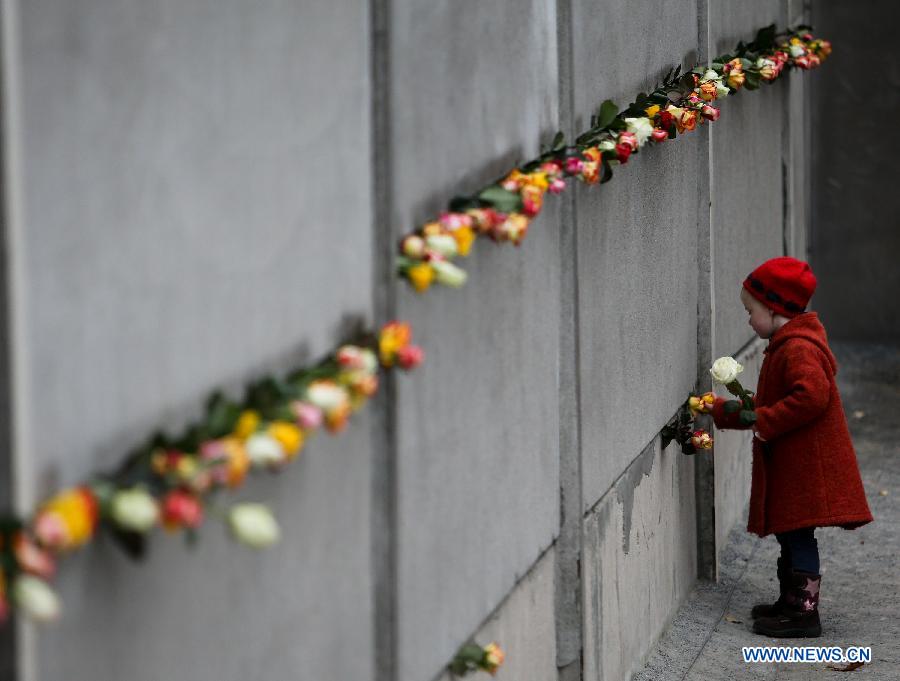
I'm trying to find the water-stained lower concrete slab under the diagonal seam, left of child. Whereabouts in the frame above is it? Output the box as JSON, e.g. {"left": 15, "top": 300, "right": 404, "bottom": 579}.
{"left": 582, "top": 439, "right": 697, "bottom": 681}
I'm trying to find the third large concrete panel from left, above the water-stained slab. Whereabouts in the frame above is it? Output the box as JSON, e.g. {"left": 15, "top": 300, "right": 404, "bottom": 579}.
{"left": 573, "top": 2, "right": 705, "bottom": 508}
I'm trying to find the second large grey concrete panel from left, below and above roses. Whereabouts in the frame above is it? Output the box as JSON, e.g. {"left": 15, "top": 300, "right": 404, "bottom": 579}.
{"left": 391, "top": 0, "right": 560, "bottom": 681}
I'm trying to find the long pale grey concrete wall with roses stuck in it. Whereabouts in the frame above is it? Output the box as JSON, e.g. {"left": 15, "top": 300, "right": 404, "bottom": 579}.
{"left": 2, "top": 0, "right": 808, "bottom": 681}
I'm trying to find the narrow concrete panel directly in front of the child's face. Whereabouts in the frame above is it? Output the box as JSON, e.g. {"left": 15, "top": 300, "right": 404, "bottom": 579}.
{"left": 709, "top": 0, "right": 787, "bottom": 357}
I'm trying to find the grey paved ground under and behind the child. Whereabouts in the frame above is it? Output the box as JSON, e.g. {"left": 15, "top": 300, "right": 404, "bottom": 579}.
{"left": 632, "top": 343, "right": 900, "bottom": 681}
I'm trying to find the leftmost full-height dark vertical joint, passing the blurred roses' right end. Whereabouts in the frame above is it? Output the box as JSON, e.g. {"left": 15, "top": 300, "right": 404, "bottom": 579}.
{"left": 369, "top": 0, "right": 398, "bottom": 681}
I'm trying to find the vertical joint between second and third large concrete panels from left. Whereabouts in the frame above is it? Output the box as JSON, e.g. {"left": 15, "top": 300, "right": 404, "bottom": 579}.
{"left": 554, "top": 0, "right": 584, "bottom": 681}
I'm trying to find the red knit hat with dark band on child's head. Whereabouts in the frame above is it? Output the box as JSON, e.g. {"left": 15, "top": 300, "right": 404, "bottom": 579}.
{"left": 744, "top": 256, "right": 816, "bottom": 317}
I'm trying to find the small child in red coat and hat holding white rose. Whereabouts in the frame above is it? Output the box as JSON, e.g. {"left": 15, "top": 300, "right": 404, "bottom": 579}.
{"left": 711, "top": 257, "right": 872, "bottom": 637}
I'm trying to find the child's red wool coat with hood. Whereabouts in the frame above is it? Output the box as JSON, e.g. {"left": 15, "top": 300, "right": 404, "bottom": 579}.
{"left": 712, "top": 312, "right": 872, "bottom": 537}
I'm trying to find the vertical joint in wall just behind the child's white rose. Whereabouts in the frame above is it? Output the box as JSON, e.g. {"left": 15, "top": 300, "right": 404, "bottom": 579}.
{"left": 694, "top": 0, "right": 718, "bottom": 580}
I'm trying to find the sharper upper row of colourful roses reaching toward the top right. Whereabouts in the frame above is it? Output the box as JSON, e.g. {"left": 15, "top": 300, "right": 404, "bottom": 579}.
{"left": 397, "top": 25, "right": 831, "bottom": 292}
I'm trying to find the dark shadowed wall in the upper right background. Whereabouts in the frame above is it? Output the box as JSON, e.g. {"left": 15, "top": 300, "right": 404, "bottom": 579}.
{"left": 810, "top": 0, "right": 900, "bottom": 344}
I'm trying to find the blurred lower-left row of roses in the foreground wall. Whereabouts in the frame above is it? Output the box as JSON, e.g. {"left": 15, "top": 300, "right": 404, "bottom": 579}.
{"left": 0, "top": 322, "right": 423, "bottom": 621}
